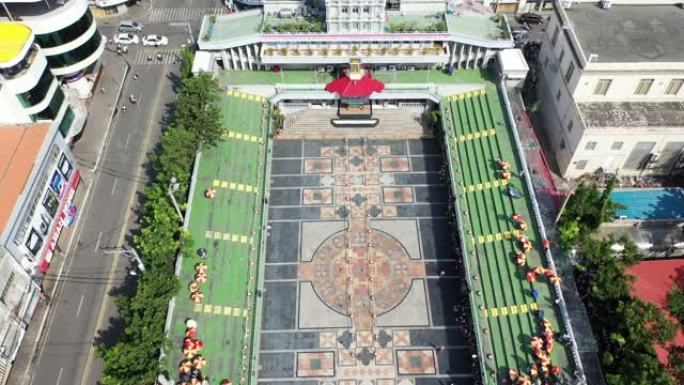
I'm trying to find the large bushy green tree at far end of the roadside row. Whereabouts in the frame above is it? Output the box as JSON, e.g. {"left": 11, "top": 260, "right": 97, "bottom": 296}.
{"left": 176, "top": 74, "right": 223, "bottom": 146}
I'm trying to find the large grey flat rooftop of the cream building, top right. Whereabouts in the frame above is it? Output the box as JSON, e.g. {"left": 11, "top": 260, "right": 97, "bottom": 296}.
{"left": 565, "top": 2, "right": 684, "bottom": 63}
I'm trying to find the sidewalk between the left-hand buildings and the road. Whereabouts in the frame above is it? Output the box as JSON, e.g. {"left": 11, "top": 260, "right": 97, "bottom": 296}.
{"left": 7, "top": 51, "right": 128, "bottom": 385}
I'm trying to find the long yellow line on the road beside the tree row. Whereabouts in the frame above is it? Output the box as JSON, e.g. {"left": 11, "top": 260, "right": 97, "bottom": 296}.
{"left": 80, "top": 60, "right": 173, "bottom": 385}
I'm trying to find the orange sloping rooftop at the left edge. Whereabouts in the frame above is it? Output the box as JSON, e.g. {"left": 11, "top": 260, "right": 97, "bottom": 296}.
{"left": 0, "top": 123, "right": 51, "bottom": 231}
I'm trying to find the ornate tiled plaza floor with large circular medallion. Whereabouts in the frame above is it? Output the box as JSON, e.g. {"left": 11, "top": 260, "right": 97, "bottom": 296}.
{"left": 258, "top": 140, "right": 473, "bottom": 385}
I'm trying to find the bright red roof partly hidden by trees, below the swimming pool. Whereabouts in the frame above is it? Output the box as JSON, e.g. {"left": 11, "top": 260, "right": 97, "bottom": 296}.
{"left": 628, "top": 259, "right": 684, "bottom": 364}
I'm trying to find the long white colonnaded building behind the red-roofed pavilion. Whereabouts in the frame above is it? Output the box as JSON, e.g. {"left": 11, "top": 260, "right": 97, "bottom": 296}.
{"left": 195, "top": 0, "right": 513, "bottom": 71}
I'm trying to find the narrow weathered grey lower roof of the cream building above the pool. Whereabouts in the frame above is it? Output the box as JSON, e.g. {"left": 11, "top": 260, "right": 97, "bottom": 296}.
{"left": 578, "top": 101, "right": 684, "bottom": 128}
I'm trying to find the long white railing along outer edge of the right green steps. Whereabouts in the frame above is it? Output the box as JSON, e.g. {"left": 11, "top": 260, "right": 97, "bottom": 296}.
{"left": 499, "top": 77, "right": 586, "bottom": 384}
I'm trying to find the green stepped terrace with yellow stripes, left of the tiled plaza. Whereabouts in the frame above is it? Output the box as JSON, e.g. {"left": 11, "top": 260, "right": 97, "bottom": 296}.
{"left": 166, "top": 91, "right": 268, "bottom": 384}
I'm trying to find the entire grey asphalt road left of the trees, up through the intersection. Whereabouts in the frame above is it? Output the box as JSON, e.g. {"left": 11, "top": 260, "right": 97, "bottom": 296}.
{"left": 26, "top": 0, "right": 221, "bottom": 385}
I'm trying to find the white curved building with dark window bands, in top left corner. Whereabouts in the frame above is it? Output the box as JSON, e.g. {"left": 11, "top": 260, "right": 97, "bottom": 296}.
{"left": 0, "top": 0, "right": 106, "bottom": 97}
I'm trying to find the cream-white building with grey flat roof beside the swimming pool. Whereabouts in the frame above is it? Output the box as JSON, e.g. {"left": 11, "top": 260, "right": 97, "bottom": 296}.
{"left": 537, "top": 2, "right": 684, "bottom": 178}
